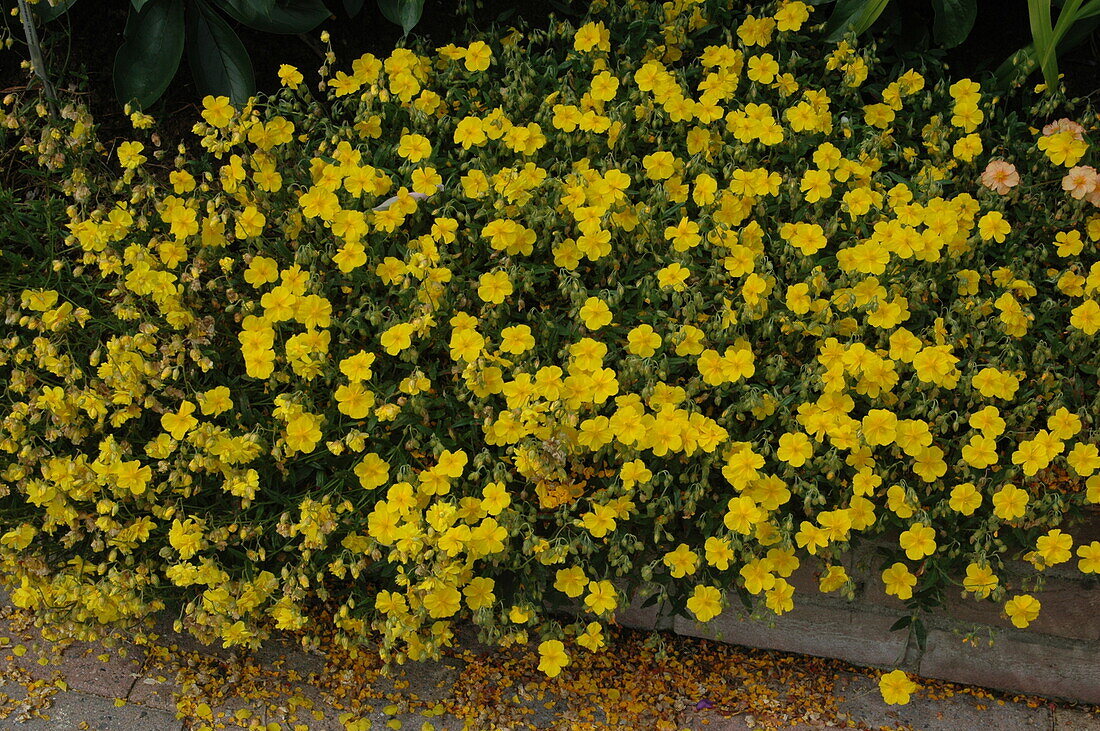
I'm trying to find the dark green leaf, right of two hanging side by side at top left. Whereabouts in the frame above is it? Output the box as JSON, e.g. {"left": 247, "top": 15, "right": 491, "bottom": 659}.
{"left": 187, "top": 0, "right": 256, "bottom": 108}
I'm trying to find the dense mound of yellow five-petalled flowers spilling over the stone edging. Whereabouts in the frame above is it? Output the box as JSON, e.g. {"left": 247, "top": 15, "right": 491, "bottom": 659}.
{"left": 0, "top": 0, "right": 1100, "bottom": 699}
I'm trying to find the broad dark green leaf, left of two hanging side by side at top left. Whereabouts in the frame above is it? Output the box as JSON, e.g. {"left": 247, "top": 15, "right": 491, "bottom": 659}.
{"left": 114, "top": 0, "right": 184, "bottom": 109}
